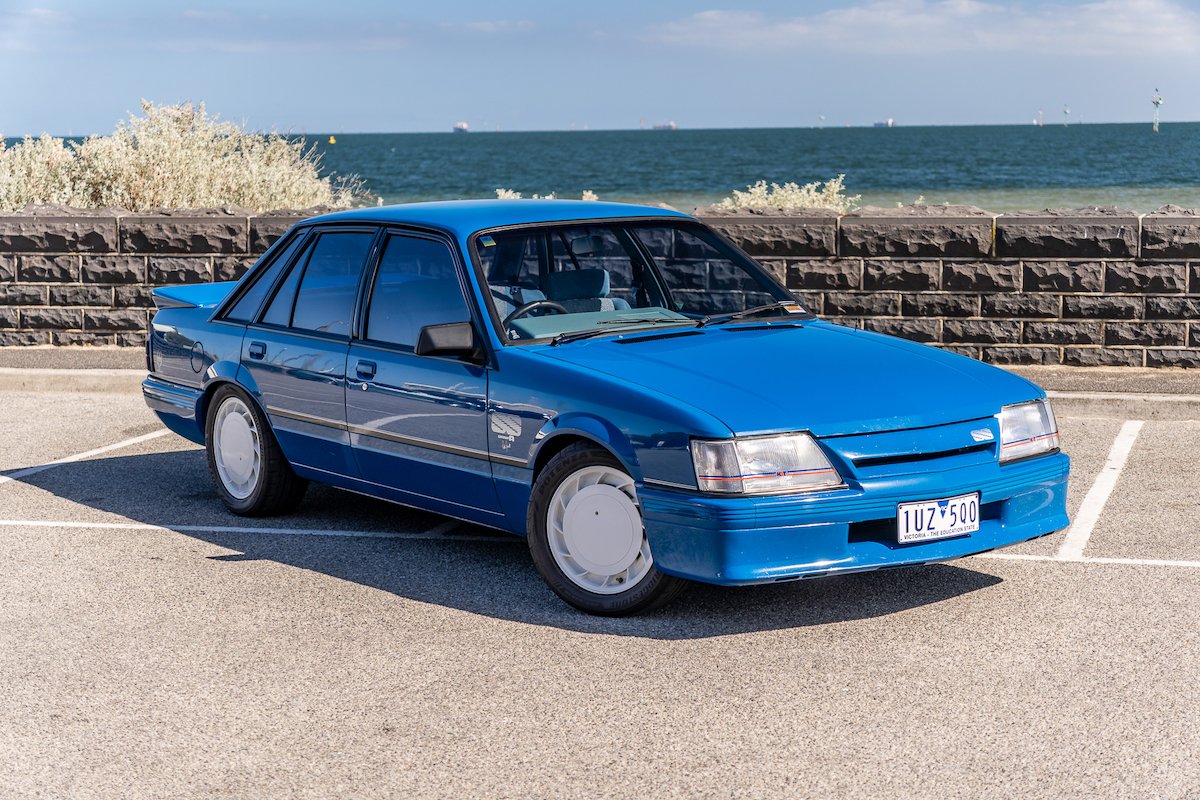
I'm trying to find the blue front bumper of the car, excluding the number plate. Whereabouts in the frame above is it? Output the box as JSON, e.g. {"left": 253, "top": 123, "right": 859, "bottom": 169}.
{"left": 638, "top": 453, "right": 1070, "bottom": 585}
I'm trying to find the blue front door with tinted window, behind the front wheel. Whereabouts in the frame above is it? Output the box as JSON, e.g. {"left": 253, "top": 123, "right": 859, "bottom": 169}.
{"left": 346, "top": 233, "right": 499, "bottom": 518}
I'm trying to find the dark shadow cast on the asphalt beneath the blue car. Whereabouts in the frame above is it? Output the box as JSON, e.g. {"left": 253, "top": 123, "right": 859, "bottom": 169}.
{"left": 9, "top": 450, "right": 1001, "bottom": 639}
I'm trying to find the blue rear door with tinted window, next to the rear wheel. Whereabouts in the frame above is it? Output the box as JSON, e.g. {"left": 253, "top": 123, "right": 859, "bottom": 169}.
{"left": 241, "top": 228, "right": 377, "bottom": 476}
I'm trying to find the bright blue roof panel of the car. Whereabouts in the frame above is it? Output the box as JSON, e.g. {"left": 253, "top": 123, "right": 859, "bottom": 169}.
{"left": 304, "top": 200, "right": 691, "bottom": 237}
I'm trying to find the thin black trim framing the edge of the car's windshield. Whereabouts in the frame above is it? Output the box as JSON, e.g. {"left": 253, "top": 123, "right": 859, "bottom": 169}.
{"left": 464, "top": 215, "right": 801, "bottom": 347}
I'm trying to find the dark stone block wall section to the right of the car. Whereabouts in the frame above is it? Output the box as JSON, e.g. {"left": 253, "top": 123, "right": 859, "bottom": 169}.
{"left": 706, "top": 206, "right": 1200, "bottom": 367}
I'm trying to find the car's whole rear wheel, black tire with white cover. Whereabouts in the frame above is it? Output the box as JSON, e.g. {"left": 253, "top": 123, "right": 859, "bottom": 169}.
{"left": 204, "top": 386, "right": 308, "bottom": 517}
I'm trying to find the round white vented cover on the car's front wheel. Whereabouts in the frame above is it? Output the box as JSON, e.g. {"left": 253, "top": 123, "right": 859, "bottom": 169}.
{"left": 546, "top": 467, "right": 654, "bottom": 595}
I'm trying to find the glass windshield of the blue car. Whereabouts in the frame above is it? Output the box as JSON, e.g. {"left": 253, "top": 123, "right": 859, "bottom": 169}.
{"left": 474, "top": 221, "right": 810, "bottom": 342}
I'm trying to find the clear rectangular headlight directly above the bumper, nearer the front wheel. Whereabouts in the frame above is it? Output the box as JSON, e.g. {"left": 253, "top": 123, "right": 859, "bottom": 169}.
{"left": 691, "top": 433, "right": 841, "bottom": 494}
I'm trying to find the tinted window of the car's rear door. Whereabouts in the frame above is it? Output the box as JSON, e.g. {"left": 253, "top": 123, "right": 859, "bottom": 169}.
{"left": 263, "top": 231, "right": 374, "bottom": 336}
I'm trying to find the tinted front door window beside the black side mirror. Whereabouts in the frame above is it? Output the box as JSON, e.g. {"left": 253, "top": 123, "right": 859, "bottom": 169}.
{"left": 366, "top": 235, "right": 470, "bottom": 350}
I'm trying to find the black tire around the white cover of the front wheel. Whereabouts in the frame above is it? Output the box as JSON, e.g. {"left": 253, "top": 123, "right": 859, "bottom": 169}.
{"left": 526, "top": 443, "right": 688, "bottom": 616}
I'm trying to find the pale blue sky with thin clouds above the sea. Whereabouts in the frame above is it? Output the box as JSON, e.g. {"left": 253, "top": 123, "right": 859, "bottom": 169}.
{"left": 0, "top": 0, "right": 1200, "bottom": 136}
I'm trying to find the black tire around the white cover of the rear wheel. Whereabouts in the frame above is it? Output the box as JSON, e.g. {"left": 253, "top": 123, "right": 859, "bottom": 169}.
{"left": 204, "top": 385, "right": 308, "bottom": 517}
